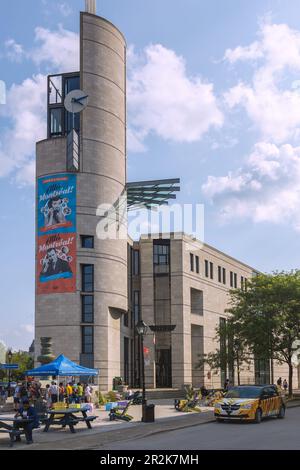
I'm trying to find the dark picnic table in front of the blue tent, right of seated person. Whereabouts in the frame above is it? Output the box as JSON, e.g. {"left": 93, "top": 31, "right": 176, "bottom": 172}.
{"left": 44, "top": 407, "right": 97, "bottom": 433}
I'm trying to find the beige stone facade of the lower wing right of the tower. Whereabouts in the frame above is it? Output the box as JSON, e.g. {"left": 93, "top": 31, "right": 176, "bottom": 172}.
{"left": 122, "top": 233, "right": 298, "bottom": 388}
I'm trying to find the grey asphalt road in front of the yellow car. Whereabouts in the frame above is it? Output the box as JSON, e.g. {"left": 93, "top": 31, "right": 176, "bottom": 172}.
{"left": 101, "top": 408, "right": 300, "bottom": 450}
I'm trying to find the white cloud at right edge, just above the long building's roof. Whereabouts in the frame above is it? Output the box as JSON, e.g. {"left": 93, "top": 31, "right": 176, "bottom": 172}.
{"left": 202, "top": 142, "right": 300, "bottom": 230}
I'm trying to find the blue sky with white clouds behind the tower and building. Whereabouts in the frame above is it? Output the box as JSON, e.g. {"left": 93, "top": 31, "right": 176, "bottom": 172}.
{"left": 0, "top": 0, "right": 300, "bottom": 348}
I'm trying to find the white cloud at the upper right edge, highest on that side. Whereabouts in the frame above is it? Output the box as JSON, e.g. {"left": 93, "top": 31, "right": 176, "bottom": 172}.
{"left": 224, "top": 23, "right": 300, "bottom": 143}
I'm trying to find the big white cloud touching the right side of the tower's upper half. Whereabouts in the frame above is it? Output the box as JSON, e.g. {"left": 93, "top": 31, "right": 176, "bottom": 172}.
{"left": 128, "top": 44, "right": 224, "bottom": 151}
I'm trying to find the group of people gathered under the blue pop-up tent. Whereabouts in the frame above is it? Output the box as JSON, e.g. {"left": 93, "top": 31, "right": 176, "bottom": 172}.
{"left": 14, "top": 381, "right": 93, "bottom": 411}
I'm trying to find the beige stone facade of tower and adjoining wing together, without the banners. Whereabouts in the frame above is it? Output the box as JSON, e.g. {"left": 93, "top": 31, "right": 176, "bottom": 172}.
{"left": 35, "top": 13, "right": 298, "bottom": 390}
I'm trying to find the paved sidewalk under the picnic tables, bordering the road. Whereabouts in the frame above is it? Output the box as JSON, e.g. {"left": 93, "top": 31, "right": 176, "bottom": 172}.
{"left": 0, "top": 400, "right": 214, "bottom": 451}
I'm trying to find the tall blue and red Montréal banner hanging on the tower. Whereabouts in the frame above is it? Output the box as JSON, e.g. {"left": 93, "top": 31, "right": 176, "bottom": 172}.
{"left": 37, "top": 173, "right": 76, "bottom": 295}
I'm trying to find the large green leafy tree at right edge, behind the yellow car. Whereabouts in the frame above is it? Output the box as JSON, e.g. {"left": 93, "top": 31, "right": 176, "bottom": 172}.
{"left": 227, "top": 271, "right": 300, "bottom": 396}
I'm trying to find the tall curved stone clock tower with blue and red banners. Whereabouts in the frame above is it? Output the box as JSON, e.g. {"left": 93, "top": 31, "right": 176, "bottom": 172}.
{"left": 35, "top": 12, "right": 128, "bottom": 390}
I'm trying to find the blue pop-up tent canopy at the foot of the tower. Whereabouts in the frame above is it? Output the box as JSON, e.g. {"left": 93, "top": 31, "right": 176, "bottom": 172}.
{"left": 25, "top": 354, "right": 99, "bottom": 377}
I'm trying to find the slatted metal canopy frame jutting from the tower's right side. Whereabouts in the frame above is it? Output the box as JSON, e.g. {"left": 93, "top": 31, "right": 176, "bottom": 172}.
{"left": 126, "top": 178, "right": 180, "bottom": 211}
